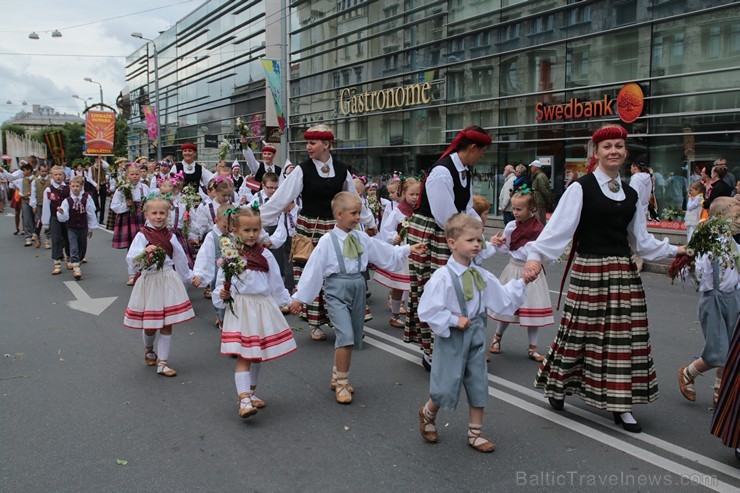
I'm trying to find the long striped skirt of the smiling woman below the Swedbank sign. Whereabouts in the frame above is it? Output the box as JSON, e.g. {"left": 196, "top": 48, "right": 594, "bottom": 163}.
{"left": 535, "top": 255, "right": 658, "bottom": 412}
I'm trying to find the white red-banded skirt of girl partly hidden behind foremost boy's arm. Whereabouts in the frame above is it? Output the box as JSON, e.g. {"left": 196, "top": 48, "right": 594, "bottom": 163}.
{"left": 488, "top": 259, "right": 555, "bottom": 327}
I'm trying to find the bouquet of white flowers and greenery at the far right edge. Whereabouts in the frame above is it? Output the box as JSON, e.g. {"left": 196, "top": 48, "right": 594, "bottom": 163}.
{"left": 668, "top": 216, "right": 739, "bottom": 286}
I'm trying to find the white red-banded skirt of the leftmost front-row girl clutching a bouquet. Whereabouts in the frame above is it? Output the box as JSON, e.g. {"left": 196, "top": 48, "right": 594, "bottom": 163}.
{"left": 123, "top": 265, "right": 195, "bottom": 330}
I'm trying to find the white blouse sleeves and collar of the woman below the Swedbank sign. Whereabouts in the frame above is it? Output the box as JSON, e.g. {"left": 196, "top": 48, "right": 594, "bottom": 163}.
{"left": 527, "top": 168, "right": 678, "bottom": 262}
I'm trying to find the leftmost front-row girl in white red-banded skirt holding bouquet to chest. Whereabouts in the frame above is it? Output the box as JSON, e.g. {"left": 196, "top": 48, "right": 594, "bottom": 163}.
{"left": 123, "top": 195, "right": 195, "bottom": 377}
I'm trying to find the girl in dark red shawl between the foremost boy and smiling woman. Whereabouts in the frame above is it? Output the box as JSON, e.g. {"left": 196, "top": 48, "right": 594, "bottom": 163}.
{"left": 482, "top": 185, "right": 555, "bottom": 362}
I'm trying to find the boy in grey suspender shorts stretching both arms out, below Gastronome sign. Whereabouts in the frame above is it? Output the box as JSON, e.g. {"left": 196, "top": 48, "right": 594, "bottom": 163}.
{"left": 290, "top": 192, "right": 426, "bottom": 404}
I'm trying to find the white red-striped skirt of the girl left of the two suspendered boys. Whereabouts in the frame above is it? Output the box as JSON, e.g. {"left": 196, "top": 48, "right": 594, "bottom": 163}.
{"left": 221, "top": 294, "right": 296, "bottom": 361}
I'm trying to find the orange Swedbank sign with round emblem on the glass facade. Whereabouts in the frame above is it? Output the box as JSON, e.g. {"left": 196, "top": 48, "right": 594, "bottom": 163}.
{"left": 534, "top": 82, "right": 644, "bottom": 123}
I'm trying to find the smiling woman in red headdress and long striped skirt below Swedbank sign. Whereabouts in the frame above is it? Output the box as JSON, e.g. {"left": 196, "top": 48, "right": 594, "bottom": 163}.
{"left": 524, "top": 125, "right": 686, "bottom": 433}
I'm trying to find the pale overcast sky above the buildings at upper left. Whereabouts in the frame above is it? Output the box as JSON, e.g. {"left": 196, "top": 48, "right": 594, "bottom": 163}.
{"left": 0, "top": 0, "right": 205, "bottom": 122}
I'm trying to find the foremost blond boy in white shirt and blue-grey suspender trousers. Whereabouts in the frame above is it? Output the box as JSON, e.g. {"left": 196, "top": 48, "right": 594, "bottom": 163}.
{"left": 419, "top": 213, "right": 526, "bottom": 452}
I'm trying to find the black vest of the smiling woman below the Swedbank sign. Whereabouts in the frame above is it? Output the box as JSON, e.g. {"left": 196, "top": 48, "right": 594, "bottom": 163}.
{"left": 576, "top": 173, "right": 638, "bottom": 257}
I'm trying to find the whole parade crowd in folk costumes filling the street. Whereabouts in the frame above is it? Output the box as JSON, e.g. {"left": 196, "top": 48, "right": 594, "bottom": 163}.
{"left": 0, "top": 125, "right": 740, "bottom": 460}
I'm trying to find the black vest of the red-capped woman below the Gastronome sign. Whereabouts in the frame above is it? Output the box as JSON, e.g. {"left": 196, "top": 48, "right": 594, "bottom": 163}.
{"left": 298, "top": 159, "right": 347, "bottom": 219}
